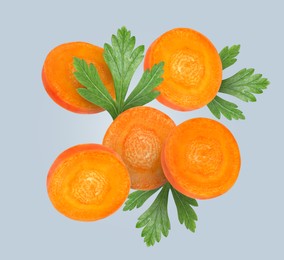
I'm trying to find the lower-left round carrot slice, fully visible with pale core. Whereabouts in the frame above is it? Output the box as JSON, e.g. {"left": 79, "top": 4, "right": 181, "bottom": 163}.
{"left": 47, "top": 144, "right": 130, "bottom": 221}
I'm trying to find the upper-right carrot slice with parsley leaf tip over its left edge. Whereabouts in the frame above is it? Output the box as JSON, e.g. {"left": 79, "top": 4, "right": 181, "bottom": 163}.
{"left": 144, "top": 28, "right": 222, "bottom": 111}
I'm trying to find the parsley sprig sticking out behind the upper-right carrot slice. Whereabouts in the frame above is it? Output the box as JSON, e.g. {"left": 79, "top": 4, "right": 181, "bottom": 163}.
{"left": 207, "top": 45, "right": 269, "bottom": 120}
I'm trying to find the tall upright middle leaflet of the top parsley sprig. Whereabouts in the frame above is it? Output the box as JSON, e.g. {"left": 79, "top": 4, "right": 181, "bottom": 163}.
{"left": 104, "top": 27, "right": 144, "bottom": 108}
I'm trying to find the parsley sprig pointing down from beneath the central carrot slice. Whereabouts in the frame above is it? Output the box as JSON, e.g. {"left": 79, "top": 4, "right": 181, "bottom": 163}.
{"left": 123, "top": 183, "right": 198, "bottom": 246}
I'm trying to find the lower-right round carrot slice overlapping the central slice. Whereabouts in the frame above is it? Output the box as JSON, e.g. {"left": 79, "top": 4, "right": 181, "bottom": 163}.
{"left": 162, "top": 118, "right": 241, "bottom": 199}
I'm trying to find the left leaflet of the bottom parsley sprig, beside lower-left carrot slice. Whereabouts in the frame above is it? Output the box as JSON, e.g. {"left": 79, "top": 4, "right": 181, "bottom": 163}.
{"left": 123, "top": 188, "right": 160, "bottom": 211}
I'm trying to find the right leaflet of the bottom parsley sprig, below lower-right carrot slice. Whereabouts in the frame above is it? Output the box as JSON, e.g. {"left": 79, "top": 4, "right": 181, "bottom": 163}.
{"left": 171, "top": 186, "right": 198, "bottom": 232}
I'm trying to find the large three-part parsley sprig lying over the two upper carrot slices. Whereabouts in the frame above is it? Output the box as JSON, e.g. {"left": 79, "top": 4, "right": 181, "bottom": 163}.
{"left": 74, "top": 27, "right": 164, "bottom": 119}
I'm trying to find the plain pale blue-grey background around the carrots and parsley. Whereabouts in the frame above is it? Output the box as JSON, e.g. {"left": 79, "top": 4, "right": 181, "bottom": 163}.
{"left": 0, "top": 0, "right": 284, "bottom": 260}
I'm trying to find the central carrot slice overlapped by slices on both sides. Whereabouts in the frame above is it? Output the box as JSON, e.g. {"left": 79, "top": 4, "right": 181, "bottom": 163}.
{"left": 103, "top": 107, "right": 175, "bottom": 190}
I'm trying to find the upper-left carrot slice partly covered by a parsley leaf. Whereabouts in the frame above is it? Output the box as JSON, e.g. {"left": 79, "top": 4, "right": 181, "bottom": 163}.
{"left": 42, "top": 42, "right": 115, "bottom": 114}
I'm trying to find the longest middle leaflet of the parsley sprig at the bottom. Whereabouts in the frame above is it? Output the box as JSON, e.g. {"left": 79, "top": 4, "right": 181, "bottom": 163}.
{"left": 136, "top": 183, "right": 171, "bottom": 246}
